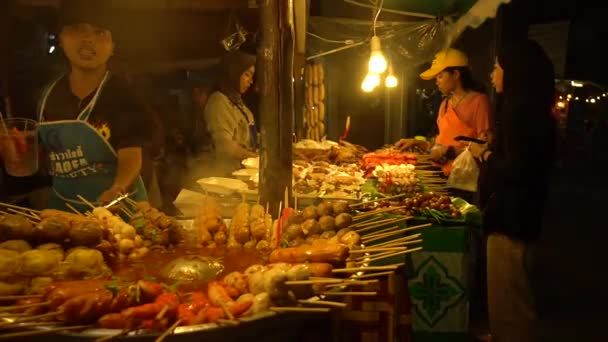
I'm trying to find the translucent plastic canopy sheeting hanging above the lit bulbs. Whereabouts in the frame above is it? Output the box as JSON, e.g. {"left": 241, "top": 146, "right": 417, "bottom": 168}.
{"left": 307, "top": 0, "right": 511, "bottom": 65}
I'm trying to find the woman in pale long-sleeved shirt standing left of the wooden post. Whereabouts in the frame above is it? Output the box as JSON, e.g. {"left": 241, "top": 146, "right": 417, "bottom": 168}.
{"left": 204, "top": 51, "right": 257, "bottom": 176}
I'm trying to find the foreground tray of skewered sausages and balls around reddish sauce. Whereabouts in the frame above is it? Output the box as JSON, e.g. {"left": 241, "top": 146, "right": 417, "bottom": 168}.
{"left": 0, "top": 201, "right": 428, "bottom": 339}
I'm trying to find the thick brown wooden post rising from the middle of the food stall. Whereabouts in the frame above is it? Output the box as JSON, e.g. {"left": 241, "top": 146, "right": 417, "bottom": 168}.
{"left": 257, "top": 0, "right": 293, "bottom": 216}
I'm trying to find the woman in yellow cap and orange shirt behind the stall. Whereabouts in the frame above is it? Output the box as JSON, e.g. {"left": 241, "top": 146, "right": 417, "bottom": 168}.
{"left": 397, "top": 49, "right": 490, "bottom": 176}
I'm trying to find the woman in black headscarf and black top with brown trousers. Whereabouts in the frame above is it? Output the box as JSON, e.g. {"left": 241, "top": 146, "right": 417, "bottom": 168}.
{"left": 471, "top": 40, "right": 556, "bottom": 342}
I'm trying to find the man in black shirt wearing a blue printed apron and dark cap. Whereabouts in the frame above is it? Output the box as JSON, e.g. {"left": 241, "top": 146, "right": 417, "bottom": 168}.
{"left": 31, "top": 1, "right": 150, "bottom": 211}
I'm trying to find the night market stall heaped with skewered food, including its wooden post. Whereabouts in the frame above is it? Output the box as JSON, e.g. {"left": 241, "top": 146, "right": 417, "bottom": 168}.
{"left": 0, "top": 2, "right": 508, "bottom": 340}
